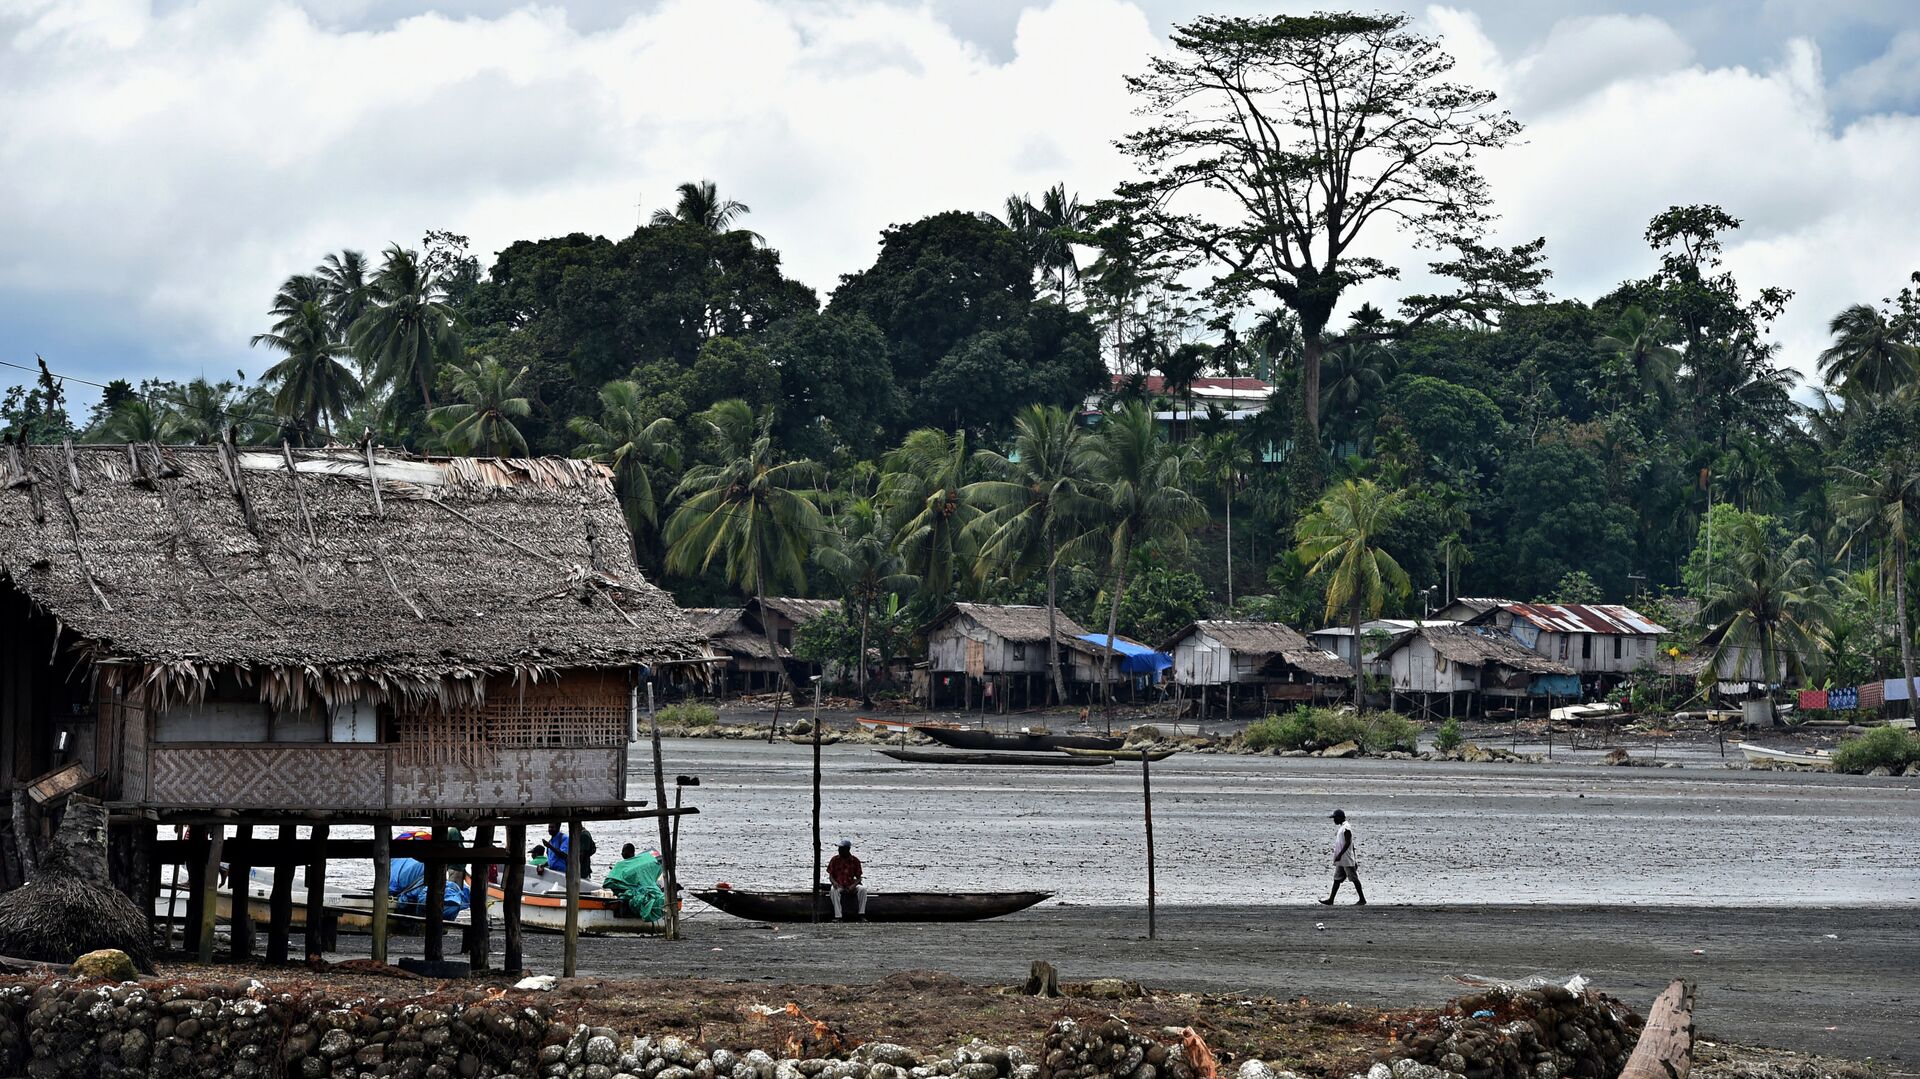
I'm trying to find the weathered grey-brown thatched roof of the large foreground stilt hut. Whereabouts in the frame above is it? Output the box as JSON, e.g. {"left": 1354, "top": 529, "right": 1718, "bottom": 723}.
{"left": 0, "top": 445, "right": 705, "bottom": 703}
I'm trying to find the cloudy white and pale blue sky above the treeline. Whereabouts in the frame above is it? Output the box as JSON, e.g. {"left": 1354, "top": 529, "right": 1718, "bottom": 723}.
{"left": 0, "top": 0, "right": 1920, "bottom": 407}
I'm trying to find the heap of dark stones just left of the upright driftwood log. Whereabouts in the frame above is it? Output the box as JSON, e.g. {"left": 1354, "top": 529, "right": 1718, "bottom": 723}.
{"left": 1367, "top": 985, "right": 1642, "bottom": 1079}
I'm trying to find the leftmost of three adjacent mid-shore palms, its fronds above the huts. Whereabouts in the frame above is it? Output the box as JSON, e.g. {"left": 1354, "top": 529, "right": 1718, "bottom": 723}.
{"left": 879, "top": 428, "right": 981, "bottom": 597}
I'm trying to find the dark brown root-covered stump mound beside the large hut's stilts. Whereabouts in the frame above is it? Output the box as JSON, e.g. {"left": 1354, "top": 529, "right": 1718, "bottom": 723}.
{"left": 0, "top": 797, "right": 154, "bottom": 973}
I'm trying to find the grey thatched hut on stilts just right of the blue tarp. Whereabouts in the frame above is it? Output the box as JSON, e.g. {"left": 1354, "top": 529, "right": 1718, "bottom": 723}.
{"left": 1160, "top": 620, "right": 1354, "bottom": 718}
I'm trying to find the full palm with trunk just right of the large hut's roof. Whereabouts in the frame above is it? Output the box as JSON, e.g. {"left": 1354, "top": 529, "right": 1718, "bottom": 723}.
{"left": 666, "top": 399, "right": 826, "bottom": 702}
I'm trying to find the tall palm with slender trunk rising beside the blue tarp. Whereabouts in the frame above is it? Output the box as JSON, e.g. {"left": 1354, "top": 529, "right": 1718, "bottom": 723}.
{"left": 1091, "top": 403, "right": 1206, "bottom": 695}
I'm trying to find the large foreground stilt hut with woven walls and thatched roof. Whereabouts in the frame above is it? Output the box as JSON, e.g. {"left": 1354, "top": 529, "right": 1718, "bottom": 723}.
{"left": 0, "top": 437, "right": 705, "bottom": 964}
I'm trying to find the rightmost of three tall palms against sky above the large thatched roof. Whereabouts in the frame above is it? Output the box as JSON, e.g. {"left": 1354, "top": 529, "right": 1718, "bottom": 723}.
{"left": 348, "top": 244, "right": 459, "bottom": 409}
